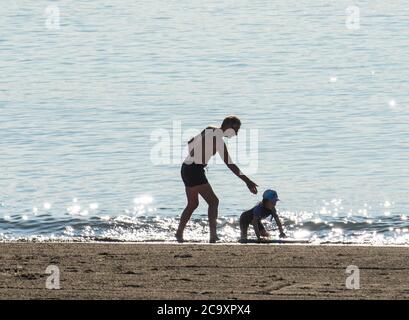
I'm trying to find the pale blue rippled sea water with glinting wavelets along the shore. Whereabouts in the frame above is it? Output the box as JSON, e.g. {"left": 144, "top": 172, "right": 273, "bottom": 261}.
{"left": 0, "top": 0, "right": 409, "bottom": 244}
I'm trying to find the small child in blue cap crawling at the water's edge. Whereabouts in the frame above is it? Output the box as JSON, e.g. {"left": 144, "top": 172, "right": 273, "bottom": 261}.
{"left": 240, "top": 189, "right": 287, "bottom": 243}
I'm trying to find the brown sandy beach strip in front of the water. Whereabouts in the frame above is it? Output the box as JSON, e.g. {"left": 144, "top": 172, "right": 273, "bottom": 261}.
{"left": 0, "top": 243, "right": 409, "bottom": 300}
